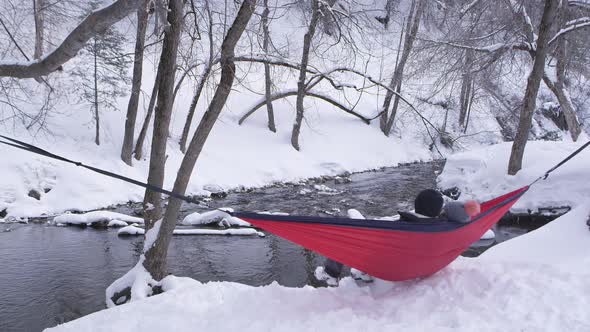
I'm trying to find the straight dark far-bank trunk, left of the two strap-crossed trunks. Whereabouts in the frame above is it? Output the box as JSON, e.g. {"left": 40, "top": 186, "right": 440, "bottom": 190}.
{"left": 121, "top": 0, "right": 148, "bottom": 166}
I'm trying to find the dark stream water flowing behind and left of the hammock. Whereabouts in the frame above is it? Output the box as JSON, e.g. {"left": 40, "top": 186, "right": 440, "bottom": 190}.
{"left": 0, "top": 162, "right": 552, "bottom": 332}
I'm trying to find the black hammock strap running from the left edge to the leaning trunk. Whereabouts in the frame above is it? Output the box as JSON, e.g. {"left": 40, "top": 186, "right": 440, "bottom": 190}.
{"left": 0, "top": 135, "right": 199, "bottom": 204}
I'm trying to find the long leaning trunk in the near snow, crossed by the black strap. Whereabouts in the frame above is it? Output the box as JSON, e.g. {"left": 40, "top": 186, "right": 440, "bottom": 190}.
{"left": 146, "top": 0, "right": 256, "bottom": 280}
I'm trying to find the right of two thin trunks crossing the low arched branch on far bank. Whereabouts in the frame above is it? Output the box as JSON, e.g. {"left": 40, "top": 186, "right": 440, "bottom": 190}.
{"left": 291, "top": 0, "right": 320, "bottom": 151}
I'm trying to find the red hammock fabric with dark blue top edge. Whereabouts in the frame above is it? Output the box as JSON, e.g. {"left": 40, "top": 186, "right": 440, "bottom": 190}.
{"left": 233, "top": 186, "right": 529, "bottom": 281}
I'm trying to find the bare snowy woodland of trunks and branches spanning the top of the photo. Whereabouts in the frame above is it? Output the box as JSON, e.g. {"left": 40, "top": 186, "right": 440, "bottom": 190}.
{"left": 0, "top": 0, "right": 590, "bottom": 304}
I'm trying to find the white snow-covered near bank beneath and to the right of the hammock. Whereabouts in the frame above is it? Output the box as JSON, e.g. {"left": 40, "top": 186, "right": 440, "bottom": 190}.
{"left": 47, "top": 142, "right": 590, "bottom": 332}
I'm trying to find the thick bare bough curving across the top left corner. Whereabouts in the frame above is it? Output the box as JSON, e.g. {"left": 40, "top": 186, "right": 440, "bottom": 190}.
{"left": 0, "top": 0, "right": 139, "bottom": 78}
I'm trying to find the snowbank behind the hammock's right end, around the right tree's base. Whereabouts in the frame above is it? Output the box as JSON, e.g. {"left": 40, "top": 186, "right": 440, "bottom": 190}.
{"left": 438, "top": 138, "right": 590, "bottom": 211}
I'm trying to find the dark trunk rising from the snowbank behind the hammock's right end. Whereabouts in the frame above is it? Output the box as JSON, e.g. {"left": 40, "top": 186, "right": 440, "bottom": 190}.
{"left": 508, "top": 0, "right": 558, "bottom": 175}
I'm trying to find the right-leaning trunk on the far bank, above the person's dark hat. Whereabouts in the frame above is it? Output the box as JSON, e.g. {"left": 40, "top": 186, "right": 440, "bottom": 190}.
{"left": 379, "top": 0, "right": 424, "bottom": 136}
